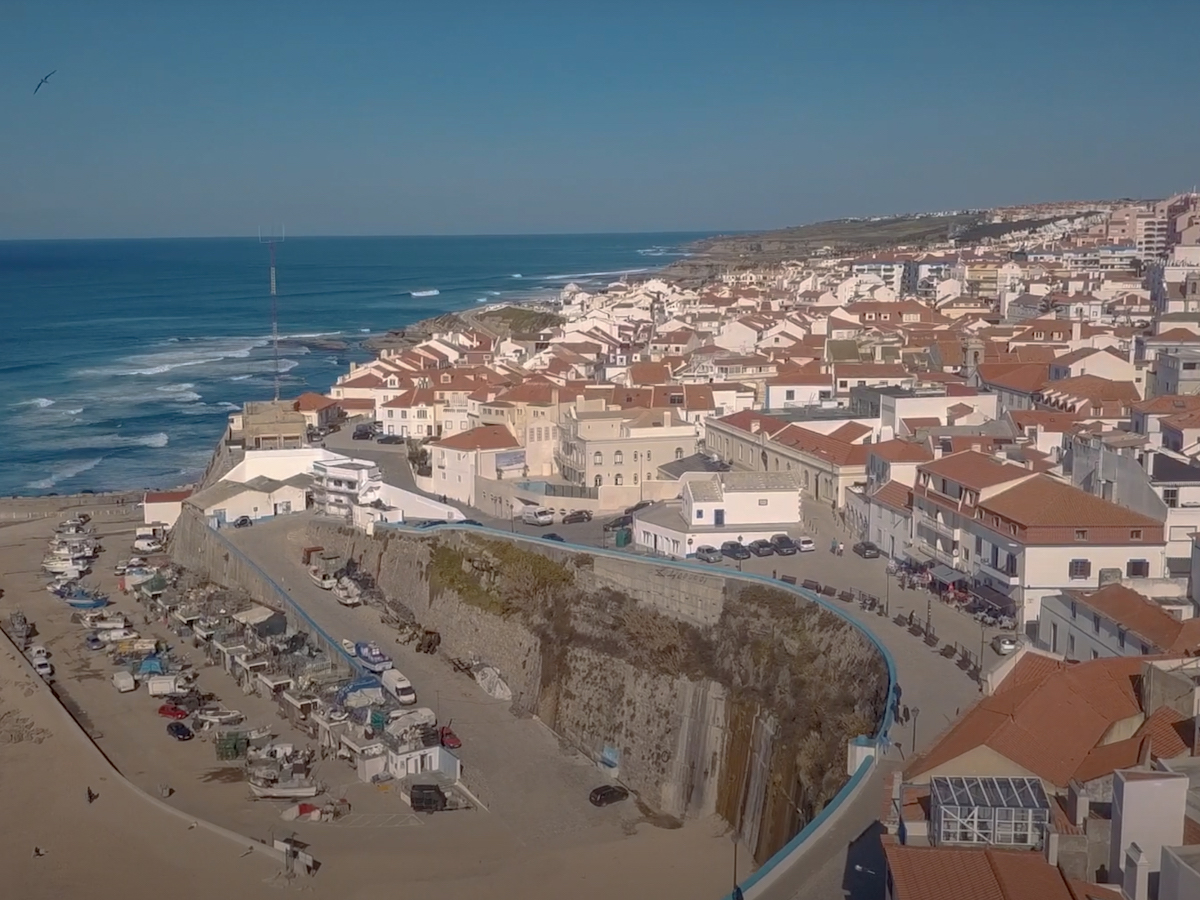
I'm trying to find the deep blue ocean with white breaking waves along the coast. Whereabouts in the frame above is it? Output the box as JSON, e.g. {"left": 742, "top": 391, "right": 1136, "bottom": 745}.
{"left": 0, "top": 234, "right": 707, "bottom": 496}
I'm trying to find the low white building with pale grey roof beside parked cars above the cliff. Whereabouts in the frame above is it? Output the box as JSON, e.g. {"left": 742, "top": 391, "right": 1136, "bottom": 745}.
{"left": 634, "top": 472, "right": 800, "bottom": 558}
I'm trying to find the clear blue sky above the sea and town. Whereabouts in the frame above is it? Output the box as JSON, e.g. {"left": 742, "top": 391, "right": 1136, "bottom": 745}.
{"left": 0, "top": 0, "right": 1200, "bottom": 239}
